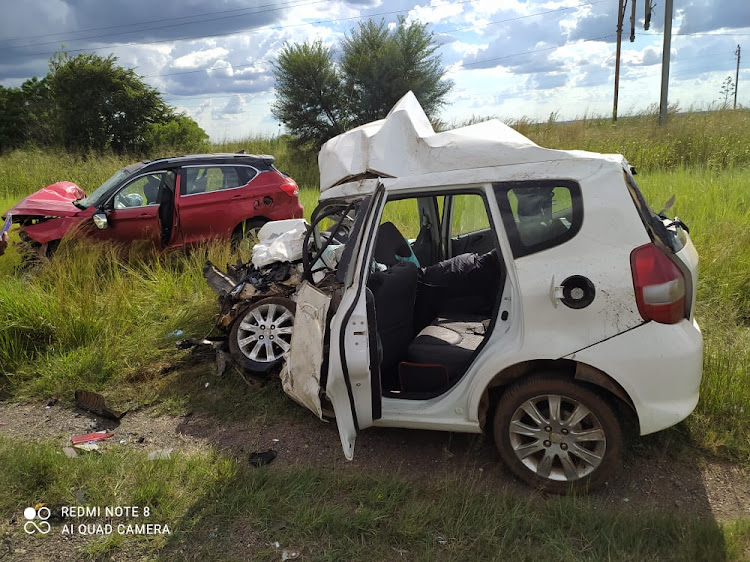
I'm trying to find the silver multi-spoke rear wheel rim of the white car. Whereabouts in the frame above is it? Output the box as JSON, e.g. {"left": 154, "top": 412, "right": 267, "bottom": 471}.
{"left": 508, "top": 394, "right": 607, "bottom": 482}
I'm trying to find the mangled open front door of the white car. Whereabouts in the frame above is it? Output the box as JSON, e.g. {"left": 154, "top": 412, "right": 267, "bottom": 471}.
{"left": 280, "top": 185, "right": 385, "bottom": 460}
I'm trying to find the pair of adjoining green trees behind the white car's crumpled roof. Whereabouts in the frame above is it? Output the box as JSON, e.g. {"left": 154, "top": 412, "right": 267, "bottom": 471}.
{"left": 272, "top": 18, "right": 453, "bottom": 148}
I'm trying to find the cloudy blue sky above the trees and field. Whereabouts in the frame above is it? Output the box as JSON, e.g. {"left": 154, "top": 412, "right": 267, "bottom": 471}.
{"left": 0, "top": 0, "right": 750, "bottom": 142}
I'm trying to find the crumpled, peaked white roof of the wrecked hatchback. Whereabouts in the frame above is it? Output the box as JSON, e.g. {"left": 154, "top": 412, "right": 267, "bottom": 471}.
{"left": 318, "top": 92, "right": 622, "bottom": 192}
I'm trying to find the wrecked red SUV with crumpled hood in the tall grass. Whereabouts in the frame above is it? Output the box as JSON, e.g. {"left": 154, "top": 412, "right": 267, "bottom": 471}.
{"left": 4, "top": 153, "right": 303, "bottom": 255}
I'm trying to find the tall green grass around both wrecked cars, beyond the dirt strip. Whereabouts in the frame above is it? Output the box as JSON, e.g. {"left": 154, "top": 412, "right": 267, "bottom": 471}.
{"left": 0, "top": 111, "right": 750, "bottom": 465}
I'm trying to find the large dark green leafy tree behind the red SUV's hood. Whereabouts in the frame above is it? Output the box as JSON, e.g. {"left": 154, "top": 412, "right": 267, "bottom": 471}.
{"left": 47, "top": 52, "right": 173, "bottom": 152}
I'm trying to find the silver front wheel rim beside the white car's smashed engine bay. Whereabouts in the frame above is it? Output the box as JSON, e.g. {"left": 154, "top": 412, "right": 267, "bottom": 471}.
{"left": 237, "top": 303, "right": 294, "bottom": 363}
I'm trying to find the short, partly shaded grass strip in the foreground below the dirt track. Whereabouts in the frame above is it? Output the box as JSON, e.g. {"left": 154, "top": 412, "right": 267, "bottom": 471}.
{"left": 0, "top": 439, "right": 750, "bottom": 561}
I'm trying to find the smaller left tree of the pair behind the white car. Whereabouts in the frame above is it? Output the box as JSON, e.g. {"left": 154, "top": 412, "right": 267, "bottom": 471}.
{"left": 271, "top": 40, "right": 350, "bottom": 149}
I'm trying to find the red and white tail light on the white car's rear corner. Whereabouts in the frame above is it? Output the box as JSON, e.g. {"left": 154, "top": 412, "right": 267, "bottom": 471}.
{"left": 630, "top": 244, "right": 685, "bottom": 324}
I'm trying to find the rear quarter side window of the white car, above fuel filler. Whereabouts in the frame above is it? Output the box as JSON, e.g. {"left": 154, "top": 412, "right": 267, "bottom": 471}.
{"left": 494, "top": 180, "right": 583, "bottom": 257}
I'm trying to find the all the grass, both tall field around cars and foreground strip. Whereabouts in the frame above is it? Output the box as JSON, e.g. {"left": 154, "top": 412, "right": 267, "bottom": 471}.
{"left": 0, "top": 111, "right": 750, "bottom": 560}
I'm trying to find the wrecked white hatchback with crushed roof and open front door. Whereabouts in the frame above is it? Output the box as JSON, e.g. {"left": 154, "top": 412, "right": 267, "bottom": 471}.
{"left": 228, "top": 93, "right": 702, "bottom": 492}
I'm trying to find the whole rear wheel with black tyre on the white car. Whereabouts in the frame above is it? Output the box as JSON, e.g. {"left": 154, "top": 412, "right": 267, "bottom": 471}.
{"left": 493, "top": 375, "right": 623, "bottom": 494}
